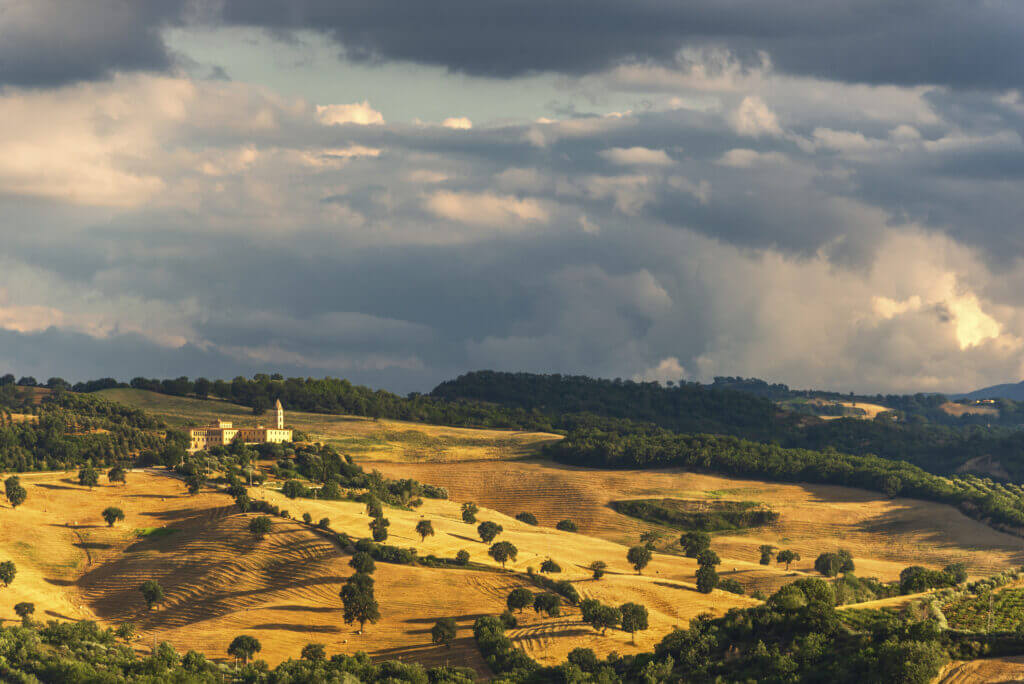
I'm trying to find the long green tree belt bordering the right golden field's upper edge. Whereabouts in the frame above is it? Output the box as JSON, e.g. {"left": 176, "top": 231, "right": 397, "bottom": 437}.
{"left": 545, "top": 428, "right": 1024, "bottom": 533}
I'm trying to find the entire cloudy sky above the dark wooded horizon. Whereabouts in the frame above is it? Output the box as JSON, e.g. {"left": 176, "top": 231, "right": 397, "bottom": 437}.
{"left": 0, "top": 0, "right": 1024, "bottom": 393}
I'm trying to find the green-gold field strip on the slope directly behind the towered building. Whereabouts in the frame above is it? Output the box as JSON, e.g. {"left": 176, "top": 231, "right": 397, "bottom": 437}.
{"left": 95, "top": 389, "right": 561, "bottom": 462}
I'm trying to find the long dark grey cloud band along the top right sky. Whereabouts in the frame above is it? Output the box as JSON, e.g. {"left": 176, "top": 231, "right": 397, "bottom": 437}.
{"left": 223, "top": 0, "right": 1024, "bottom": 88}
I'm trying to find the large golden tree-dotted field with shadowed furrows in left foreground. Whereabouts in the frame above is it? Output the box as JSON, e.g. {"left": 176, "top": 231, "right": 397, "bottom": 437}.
{"left": 0, "top": 471, "right": 754, "bottom": 674}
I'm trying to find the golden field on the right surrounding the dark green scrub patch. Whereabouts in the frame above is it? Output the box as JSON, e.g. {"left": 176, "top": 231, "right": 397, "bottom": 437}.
{"left": 374, "top": 461, "right": 1024, "bottom": 590}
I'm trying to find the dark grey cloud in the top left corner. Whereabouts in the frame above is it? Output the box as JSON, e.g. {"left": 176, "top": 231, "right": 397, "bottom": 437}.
{"left": 0, "top": 0, "right": 185, "bottom": 87}
